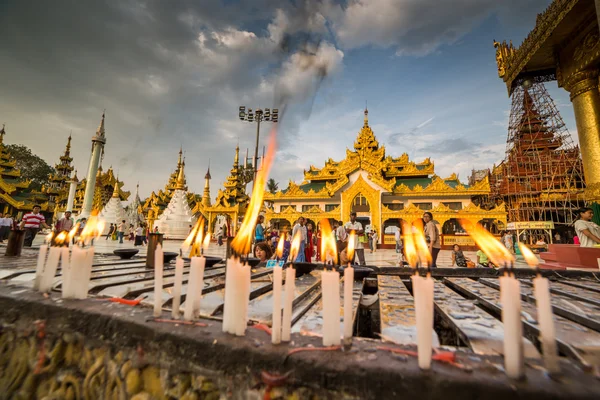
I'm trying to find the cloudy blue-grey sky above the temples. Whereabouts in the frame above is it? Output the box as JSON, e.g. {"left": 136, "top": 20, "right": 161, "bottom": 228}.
{"left": 0, "top": 0, "right": 575, "bottom": 202}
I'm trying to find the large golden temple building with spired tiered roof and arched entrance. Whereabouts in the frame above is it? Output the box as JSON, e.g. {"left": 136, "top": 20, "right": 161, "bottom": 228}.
{"left": 265, "top": 110, "right": 506, "bottom": 248}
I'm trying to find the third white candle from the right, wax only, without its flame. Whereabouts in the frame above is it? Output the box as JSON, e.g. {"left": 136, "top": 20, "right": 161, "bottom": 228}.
{"left": 411, "top": 275, "right": 433, "bottom": 370}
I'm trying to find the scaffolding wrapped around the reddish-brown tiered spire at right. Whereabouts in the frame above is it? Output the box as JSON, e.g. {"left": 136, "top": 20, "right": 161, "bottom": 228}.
{"left": 490, "top": 83, "right": 585, "bottom": 225}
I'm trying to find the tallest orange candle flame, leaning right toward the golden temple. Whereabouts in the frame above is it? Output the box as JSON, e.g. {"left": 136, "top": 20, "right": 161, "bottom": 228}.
{"left": 231, "top": 127, "right": 277, "bottom": 255}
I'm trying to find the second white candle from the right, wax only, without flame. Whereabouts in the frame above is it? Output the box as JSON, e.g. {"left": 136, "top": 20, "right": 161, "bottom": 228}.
{"left": 499, "top": 276, "right": 523, "bottom": 378}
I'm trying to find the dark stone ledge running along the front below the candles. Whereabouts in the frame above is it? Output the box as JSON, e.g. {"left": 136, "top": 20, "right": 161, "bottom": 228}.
{"left": 0, "top": 286, "right": 600, "bottom": 400}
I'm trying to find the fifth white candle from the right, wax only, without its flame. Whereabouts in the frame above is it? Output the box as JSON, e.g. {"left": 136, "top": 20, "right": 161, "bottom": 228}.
{"left": 321, "top": 271, "right": 341, "bottom": 346}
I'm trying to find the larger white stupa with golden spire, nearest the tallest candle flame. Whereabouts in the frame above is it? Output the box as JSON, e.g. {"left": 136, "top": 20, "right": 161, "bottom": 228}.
{"left": 154, "top": 161, "right": 196, "bottom": 239}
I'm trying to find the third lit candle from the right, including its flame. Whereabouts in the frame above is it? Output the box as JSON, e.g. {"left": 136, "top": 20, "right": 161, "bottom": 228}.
{"left": 411, "top": 220, "right": 434, "bottom": 370}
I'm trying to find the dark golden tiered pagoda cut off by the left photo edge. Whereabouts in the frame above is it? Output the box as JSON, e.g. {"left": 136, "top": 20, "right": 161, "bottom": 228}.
{"left": 0, "top": 125, "right": 52, "bottom": 218}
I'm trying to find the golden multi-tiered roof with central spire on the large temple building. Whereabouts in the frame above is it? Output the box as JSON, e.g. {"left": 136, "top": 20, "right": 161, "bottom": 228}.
{"left": 265, "top": 110, "right": 490, "bottom": 200}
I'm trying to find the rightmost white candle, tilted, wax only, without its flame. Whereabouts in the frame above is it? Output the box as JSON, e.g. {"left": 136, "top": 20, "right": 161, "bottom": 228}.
{"left": 533, "top": 275, "right": 560, "bottom": 374}
